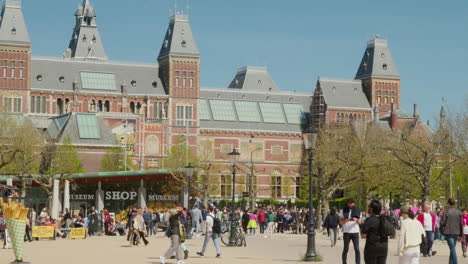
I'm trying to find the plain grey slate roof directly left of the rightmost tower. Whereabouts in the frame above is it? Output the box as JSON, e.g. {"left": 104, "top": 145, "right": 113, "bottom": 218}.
{"left": 316, "top": 78, "right": 371, "bottom": 111}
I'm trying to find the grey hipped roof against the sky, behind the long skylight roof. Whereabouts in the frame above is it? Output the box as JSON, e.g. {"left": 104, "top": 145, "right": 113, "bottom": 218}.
{"left": 228, "top": 66, "right": 279, "bottom": 92}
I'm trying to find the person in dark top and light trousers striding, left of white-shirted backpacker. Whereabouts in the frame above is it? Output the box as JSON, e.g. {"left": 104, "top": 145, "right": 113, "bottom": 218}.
{"left": 159, "top": 209, "right": 184, "bottom": 264}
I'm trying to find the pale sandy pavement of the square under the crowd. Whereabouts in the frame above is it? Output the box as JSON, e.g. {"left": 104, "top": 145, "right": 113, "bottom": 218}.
{"left": 0, "top": 234, "right": 468, "bottom": 264}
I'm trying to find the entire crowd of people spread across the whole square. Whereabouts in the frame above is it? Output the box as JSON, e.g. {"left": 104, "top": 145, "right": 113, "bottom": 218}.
{"left": 0, "top": 199, "right": 468, "bottom": 264}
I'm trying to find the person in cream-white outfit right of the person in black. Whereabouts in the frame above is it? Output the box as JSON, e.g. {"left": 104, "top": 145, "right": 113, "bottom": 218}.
{"left": 398, "top": 207, "right": 426, "bottom": 264}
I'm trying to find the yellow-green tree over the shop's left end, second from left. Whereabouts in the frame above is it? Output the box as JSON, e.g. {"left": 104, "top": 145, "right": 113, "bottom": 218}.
{"left": 34, "top": 137, "right": 84, "bottom": 202}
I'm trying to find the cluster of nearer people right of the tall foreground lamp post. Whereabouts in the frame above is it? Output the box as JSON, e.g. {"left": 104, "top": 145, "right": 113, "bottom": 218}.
{"left": 322, "top": 198, "right": 468, "bottom": 264}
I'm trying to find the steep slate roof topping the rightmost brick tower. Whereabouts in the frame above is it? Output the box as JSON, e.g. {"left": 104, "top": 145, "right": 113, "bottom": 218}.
{"left": 355, "top": 38, "right": 400, "bottom": 80}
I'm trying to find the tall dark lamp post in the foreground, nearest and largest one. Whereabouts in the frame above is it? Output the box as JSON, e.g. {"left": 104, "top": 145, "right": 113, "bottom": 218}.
{"left": 304, "top": 128, "right": 318, "bottom": 261}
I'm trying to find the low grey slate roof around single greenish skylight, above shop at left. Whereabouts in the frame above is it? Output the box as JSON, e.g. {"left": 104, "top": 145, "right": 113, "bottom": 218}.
{"left": 46, "top": 113, "right": 118, "bottom": 147}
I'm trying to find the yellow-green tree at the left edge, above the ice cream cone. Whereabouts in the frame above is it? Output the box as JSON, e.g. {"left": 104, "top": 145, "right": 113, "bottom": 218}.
{"left": 0, "top": 114, "right": 44, "bottom": 197}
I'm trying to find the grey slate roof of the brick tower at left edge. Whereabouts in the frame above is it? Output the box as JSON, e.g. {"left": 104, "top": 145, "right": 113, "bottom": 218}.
{"left": 0, "top": 0, "right": 31, "bottom": 46}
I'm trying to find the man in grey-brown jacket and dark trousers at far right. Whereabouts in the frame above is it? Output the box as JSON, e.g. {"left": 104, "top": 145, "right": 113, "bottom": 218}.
{"left": 440, "top": 198, "right": 463, "bottom": 264}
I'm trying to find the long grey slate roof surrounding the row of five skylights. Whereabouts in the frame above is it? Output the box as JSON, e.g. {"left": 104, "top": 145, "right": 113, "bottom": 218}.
{"left": 199, "top": 88, "right": 312, "bottom": 133}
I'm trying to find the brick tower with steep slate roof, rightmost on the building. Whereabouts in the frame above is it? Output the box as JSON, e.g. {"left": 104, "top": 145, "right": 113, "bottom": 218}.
{"left": 355, "top": 37, "right": 401, "bottom": 115}
